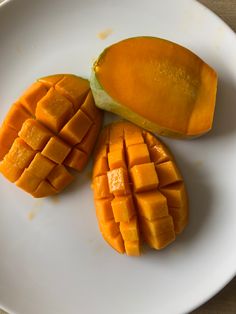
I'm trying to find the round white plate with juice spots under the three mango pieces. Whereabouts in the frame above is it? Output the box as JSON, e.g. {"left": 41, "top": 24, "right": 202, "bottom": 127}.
{"left": 0, "top": 0, "right": 236, "bottom": 314}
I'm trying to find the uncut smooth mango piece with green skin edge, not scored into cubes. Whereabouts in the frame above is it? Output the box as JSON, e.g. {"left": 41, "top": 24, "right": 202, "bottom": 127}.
{"left": 91, "top": 37, "right": 217, "bottom": 138}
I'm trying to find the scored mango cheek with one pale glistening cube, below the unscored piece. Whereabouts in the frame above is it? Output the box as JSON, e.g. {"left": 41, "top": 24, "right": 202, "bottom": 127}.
{"left": 92, "top": 121, "right": 188, "bottom": 256}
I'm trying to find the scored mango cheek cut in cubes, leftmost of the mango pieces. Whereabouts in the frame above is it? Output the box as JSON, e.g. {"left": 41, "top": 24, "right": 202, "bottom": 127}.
{"left": 0, "top": 74, "right": 102, "bottom": 197}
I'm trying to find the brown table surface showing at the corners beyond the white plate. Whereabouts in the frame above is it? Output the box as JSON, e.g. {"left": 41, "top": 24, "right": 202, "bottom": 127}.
{"left": 0, "top": 0, "right": 236, "bottom": 314}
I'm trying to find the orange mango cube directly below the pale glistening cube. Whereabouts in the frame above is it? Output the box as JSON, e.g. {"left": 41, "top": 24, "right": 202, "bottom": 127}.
{"left": 111, "top": 195, "right": 135, "bottom": 222}
